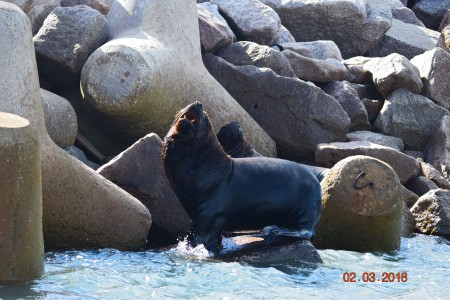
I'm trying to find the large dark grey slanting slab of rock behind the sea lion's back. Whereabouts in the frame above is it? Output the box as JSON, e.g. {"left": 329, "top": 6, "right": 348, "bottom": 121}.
{"left": 204, "top": 54, "right": 350, "bottom": 159}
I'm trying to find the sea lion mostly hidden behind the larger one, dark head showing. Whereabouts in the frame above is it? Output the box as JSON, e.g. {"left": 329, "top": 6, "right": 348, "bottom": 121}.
{"left": 217, "top": 121, "right": 330, "bottom": 181}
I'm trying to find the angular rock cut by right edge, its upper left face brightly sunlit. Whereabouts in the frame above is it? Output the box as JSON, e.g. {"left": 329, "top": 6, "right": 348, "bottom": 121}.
{"left": 411, "top": 48, "right": 450, "bottom": 109}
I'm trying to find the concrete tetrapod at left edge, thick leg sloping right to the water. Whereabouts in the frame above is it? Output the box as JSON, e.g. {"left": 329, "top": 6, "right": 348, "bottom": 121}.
{"left": 0, "top": 1, "right": 151, "bottom": 250}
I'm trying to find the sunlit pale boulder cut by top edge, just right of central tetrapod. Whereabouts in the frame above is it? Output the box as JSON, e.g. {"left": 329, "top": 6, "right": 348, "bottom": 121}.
{"left": 210, "top": 0, "right": 281, "bottom": 46}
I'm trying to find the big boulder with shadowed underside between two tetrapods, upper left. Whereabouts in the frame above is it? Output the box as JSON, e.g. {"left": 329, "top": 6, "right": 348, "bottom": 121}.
{"left": 33, "top": 6, "right": 108, "bottom": 88}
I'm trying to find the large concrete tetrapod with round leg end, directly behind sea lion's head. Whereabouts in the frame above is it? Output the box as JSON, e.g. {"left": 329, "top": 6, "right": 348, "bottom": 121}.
{"left": 81, "top": 0, "right": 275, "bottom": 156}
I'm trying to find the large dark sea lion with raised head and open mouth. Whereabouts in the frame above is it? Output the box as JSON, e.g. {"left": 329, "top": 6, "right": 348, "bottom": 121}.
{"left": 162, "top": 102, "right": 322, "bottom": 253}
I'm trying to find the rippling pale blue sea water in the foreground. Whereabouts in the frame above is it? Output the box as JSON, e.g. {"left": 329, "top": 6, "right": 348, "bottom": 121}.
{"left": 0, "top": 235, "right": 450, "bottom": 300}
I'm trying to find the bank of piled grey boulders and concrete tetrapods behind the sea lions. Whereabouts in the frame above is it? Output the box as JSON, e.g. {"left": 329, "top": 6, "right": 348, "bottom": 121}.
{"left": 0, "top": 0, "right": 450, "bottom": 279}
